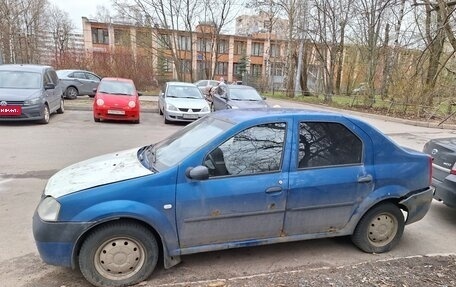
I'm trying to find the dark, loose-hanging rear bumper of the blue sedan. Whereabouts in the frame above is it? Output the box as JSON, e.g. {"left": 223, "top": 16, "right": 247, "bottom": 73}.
{"left": 399, "top": 187, "right": 434, "bottom": 224}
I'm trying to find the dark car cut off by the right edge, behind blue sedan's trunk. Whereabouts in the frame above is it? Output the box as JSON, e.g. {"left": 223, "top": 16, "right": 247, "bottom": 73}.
{"left": 423, "top": 138, "right": 456, "bottom": 208}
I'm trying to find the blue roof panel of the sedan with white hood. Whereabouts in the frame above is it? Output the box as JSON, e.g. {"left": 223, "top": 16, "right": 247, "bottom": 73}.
{"left": 212, "top": 108, "right": 349, "bottom": 123}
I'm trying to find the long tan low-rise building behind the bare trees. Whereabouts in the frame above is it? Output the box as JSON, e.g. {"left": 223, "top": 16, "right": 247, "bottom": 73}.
{"left": 82, "top": 17, "right": 286, "bottom": 85}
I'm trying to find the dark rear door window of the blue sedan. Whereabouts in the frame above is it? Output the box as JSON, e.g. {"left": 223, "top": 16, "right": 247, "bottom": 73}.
{"left": 298, "top": 122, "right": 363, "bottom": 168}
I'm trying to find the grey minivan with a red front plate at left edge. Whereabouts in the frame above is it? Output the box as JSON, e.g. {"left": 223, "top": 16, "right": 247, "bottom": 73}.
{"left": 0, "top": 65, "right": 65, "bottom": 124}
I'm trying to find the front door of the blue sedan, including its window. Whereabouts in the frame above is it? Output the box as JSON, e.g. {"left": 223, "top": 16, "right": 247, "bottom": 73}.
{"left": 177, "top": 123, "right": 288, "bottom": 248}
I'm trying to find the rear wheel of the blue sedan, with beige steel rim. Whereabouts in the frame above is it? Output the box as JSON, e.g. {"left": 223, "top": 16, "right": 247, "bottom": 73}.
{"left": 352, "top": 203, "right": 404, "bottom": 253}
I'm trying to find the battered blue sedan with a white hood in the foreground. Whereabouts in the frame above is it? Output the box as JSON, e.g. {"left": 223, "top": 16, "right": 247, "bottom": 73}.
{"left": 33, "top": 109, "right": 433, "bottom": 286}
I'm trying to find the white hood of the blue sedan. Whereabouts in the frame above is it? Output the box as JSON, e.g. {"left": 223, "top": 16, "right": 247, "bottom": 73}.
{"left": 44, "top": 148, "right": 152, "bottom": 198}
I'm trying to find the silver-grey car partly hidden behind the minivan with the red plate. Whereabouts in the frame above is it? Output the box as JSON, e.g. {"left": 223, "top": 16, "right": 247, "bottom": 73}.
{"left": 57, "top": 70, "right": 101, "bottom": 99}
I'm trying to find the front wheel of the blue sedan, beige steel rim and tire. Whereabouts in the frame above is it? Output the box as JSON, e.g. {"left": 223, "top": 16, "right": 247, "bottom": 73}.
{"left": 79, "top": 222, "right": 159, "bottom": 287}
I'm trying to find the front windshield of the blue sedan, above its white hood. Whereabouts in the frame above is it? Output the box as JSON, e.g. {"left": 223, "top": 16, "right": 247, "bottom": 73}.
{"left": 149, "top": 117, "right": 233, "bottom": 171}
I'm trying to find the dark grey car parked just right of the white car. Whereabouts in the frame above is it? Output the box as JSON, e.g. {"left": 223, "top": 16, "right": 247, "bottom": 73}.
{"left": 211, "top": 84, "right": 268, "bottom": 111}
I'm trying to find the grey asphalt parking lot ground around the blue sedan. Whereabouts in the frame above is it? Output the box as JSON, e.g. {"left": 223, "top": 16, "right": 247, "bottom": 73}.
{"left": 0, "top": 103, "right": 456, "bottom": 287}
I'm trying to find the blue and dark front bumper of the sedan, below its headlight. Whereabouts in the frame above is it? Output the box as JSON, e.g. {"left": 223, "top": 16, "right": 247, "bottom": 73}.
{"left": 33, "top": 212, "right": 92, "bottom": 268}
